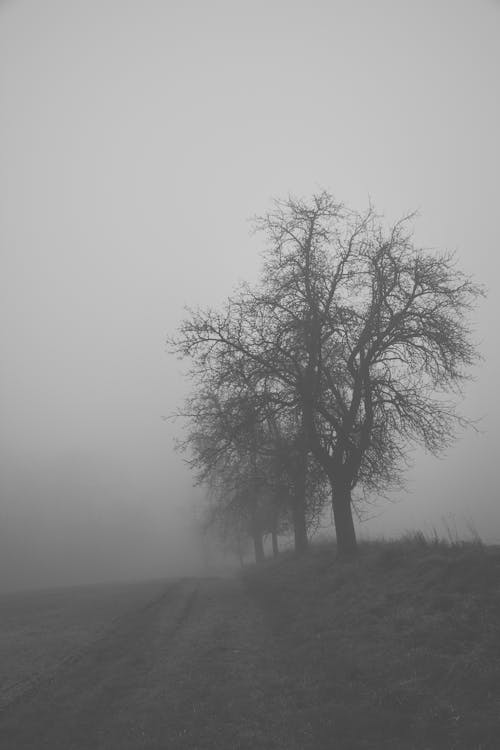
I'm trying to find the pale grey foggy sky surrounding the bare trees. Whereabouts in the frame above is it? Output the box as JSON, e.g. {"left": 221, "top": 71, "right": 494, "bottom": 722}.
{"left": 0, "top": 0, "right": 500, "bottom": 588}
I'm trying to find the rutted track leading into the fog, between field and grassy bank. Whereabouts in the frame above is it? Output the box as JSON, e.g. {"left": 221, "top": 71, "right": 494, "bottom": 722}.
{"left": 0, "top": 579, "right": 307, "bottom": 750}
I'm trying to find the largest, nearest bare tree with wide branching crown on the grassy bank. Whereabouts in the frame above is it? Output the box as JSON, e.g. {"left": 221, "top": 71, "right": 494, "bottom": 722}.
{"left": 171, "top": 192, "right": 482, "bottom": 554}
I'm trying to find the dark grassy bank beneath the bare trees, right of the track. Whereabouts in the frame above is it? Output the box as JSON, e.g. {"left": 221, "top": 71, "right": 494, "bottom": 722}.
{"left": 244, "top": 537, "right": 500, "bottom": 750}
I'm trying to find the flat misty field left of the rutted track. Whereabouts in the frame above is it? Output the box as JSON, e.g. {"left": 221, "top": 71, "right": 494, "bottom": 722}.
{"left": 0, "top": 581, "right": 169, "bottom": 709}
